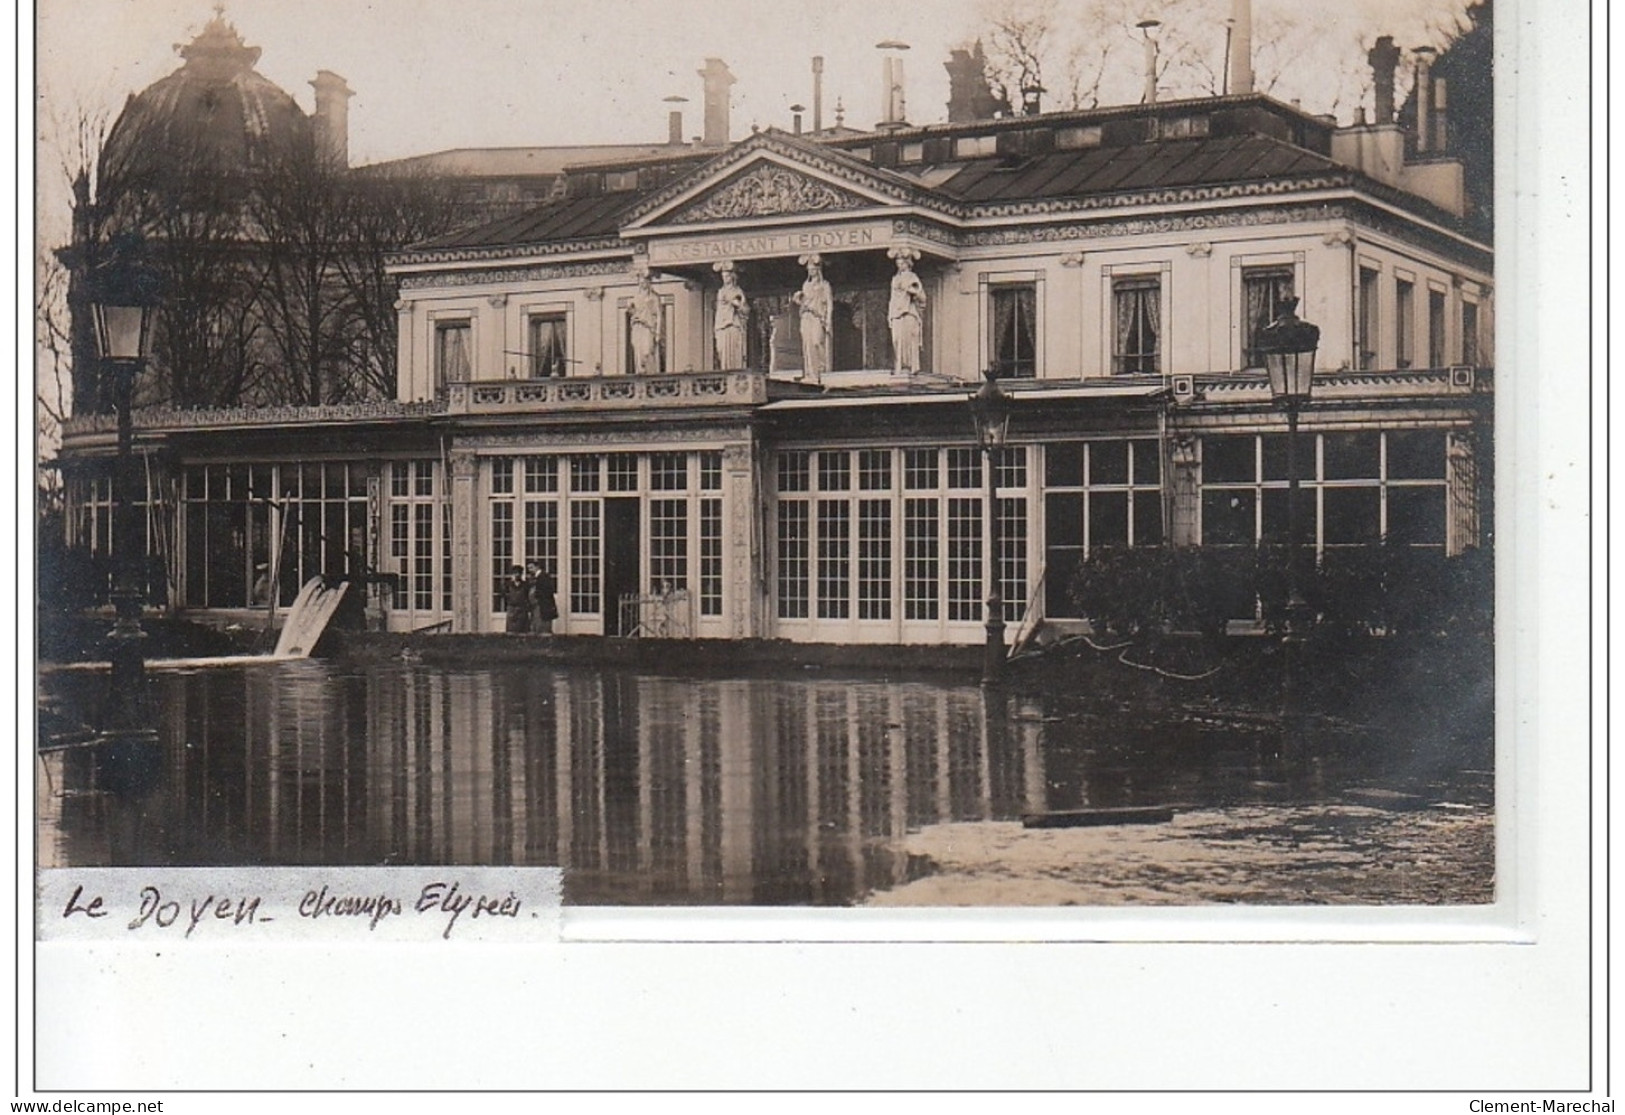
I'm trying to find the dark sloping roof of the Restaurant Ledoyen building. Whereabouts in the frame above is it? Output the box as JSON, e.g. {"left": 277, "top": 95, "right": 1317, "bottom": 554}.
{"left": 390, "top": 94, "right": 1458, "bottom": 261}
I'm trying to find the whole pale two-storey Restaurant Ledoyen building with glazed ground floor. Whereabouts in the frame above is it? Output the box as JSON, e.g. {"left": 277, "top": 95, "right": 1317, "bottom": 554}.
{"left": 63, "top": 87, "right": 1493, "bottom": 644}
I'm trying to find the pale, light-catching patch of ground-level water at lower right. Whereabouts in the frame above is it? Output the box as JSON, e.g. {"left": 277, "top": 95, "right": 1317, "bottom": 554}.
{"left": 868, "top": 803, "right": 1495, "bottom": 905}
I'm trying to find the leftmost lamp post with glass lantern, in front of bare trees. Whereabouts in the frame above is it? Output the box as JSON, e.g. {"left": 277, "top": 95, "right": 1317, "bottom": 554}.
{"left": 91, "top": 241, "right": 158, "bottom": 766}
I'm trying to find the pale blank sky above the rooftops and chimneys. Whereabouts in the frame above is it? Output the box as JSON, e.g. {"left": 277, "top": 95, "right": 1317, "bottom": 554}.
{"left": 37, "top": 0, "right": 1464, "bottom": 174}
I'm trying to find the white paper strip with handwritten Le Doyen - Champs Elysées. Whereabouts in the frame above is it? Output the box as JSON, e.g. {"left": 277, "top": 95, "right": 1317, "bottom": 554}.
{"left": 37, "top": 868, "right": 562, "bottom": 943}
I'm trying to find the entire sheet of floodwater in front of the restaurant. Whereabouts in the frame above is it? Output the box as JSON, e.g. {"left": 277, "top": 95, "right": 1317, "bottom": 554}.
{"left": 37, "top": 660, "right": 1493, "bottom": 905}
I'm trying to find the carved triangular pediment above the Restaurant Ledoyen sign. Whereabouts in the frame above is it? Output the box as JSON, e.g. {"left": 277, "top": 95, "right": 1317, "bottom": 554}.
{"left": 624, "top": 133, "right": 934, "bottom": 231}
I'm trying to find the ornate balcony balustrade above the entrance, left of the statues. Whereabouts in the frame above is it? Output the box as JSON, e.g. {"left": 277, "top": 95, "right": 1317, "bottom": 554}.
{"left": 445, "top": 371, "right": 767, "bottom": 414}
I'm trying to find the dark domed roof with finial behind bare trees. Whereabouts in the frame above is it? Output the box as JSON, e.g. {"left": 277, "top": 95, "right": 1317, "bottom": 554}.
{"left": 101, "top": 10, "right": 310, "bottom": 195}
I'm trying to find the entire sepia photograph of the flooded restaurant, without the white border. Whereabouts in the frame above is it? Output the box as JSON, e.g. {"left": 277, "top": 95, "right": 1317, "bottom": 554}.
{"left": 34, "top": 0, "right": 1498, "bottom": 913}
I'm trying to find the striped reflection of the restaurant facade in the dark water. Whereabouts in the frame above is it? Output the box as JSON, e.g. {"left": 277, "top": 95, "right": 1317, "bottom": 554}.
{"left": 42, "top": 663, "right": 1045, "bottom": 904}
